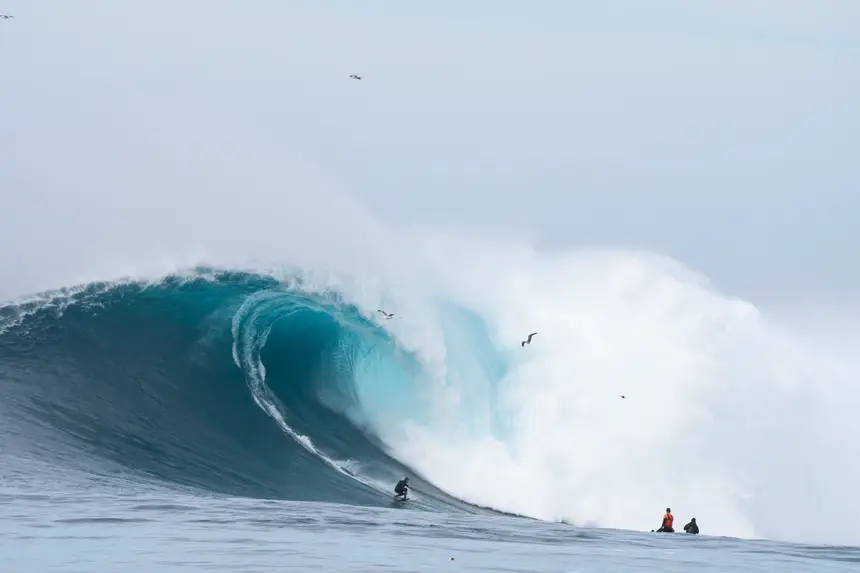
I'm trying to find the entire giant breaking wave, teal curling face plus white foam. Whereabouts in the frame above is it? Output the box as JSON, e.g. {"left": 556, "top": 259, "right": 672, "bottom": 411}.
{"left": 0, "top": 250, "right": 860, "bottom": 543}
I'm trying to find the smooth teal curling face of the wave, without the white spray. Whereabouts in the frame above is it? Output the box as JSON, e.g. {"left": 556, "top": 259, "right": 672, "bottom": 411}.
{"left": 0, "top": 271, "right": 494, "bottom": 511}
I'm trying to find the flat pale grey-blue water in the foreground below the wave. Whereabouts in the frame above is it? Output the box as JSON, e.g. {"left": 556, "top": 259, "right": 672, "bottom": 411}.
{"left": 0, "top": 492, "right": 860, "bottom": 573}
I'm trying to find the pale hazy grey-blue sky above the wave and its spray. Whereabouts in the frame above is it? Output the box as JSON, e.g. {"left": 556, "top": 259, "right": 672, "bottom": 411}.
{"left": 0, "top": 0, "right": 860, "bottom": 306}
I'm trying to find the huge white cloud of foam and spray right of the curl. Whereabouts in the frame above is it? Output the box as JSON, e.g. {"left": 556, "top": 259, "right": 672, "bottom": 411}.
{"left": 338, "top": 231, "right": 860, "bottom": 543}
